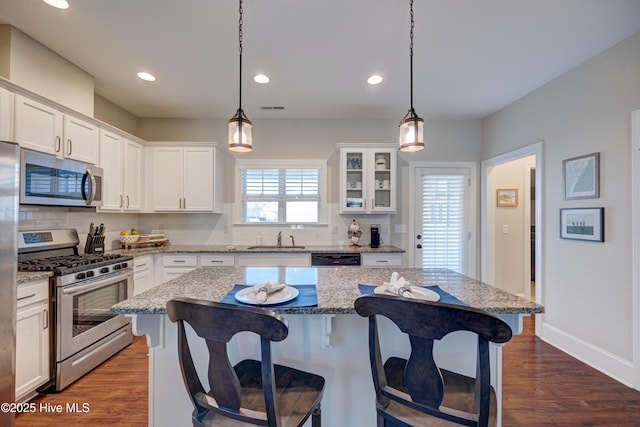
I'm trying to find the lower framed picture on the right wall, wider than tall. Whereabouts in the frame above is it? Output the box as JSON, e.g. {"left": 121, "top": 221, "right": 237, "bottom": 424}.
{"left": 560, "top": 208, "right": 604, "bottom": 242}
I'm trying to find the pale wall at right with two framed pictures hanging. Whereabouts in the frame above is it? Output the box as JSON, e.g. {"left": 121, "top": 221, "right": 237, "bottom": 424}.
{"left": 482, "top": 33, "right": 640, "bottom": 383}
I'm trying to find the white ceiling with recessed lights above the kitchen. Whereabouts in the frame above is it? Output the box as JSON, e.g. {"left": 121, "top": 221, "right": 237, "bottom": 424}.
{"left": 0, "top": 0, "right": 640, "bottom": 120}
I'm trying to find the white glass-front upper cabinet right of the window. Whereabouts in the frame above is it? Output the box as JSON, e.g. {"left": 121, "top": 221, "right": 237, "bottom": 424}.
{"left": 339, "top": 146, "right": 397, "bottom": 214}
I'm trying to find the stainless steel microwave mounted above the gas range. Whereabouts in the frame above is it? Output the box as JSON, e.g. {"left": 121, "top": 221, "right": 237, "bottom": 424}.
{"left": 20, "top": 149, "right": 103, "bottom": 207}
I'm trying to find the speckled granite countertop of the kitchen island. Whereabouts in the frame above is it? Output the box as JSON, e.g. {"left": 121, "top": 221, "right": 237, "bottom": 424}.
{"left": 111, "top": 267, "right": 544, "bottom": 314}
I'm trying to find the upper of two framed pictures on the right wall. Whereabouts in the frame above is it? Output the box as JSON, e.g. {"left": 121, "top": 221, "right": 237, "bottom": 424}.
{"left": 562, "top": 153, "right": 600, "bottom": 200}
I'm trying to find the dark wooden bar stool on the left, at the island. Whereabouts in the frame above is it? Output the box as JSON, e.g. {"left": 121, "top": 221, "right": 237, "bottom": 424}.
{"left": 167, "top": 298, "right": 324, "bottom": 427}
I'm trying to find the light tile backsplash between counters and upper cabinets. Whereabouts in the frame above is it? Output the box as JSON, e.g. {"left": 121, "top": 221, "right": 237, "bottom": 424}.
{"left": 19, "top": 204, "right": 391, "bottom": 251}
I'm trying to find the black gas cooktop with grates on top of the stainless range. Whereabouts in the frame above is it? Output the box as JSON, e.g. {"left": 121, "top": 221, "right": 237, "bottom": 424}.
{"left": 18, "top": 254, "right": 131, "bottom": 274}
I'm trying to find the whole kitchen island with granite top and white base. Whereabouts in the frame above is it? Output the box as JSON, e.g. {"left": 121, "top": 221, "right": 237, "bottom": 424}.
{"left": 111, "top": 267, "right": 544, "bottom": 427}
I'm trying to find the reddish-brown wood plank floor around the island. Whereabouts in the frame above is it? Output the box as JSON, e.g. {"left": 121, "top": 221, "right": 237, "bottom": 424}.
{"left": 16, "top": 318, "right": 640, "bottom": 427}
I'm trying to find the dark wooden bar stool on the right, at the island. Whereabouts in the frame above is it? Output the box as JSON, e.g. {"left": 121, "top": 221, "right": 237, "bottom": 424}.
{"left": 355, "top": 295, "right": 512, "bottom": 427}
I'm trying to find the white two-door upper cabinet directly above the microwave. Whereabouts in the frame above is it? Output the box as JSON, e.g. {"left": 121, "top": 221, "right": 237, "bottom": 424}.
{"left": 15, "top": 95, "right": 99, "bottom": 164}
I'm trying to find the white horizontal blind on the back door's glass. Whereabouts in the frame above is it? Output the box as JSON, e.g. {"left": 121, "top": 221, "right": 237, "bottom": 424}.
{"left": 422, "top": 174, "right": 469, "bottom": 273}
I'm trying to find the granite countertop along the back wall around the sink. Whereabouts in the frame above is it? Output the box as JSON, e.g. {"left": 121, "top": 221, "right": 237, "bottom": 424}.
{"left": 108, "top": 245, "right": 405, "bottom": 257}
